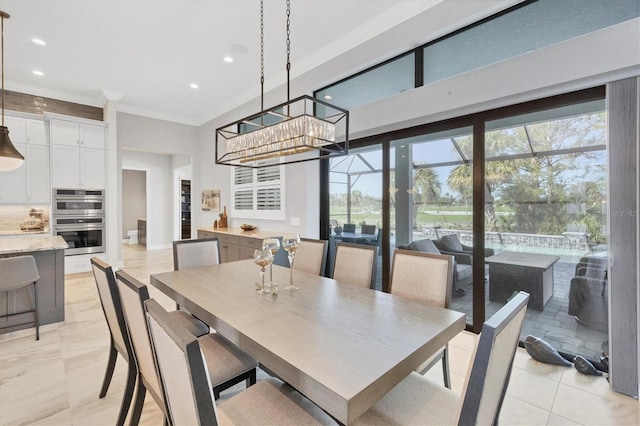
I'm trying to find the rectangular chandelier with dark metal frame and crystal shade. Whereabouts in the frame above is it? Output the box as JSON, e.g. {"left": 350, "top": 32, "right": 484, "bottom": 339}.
{"left": 216, "top": 95, "right": 349, "bottom": 168}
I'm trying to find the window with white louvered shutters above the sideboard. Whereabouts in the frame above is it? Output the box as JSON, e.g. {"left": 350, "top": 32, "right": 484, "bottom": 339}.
{"left": 231, "top": 164, "right": 284, "bottom": 220}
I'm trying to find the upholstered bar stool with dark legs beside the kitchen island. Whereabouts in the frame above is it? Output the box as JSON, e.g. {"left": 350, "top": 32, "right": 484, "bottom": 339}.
{"left": 0, "top": 256, "right": 40, "bottom": 340}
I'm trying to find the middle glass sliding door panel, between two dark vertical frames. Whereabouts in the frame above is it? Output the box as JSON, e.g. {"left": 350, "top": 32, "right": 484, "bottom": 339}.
{"left": 389, "top": 127, "right": 473, "bottom": 322}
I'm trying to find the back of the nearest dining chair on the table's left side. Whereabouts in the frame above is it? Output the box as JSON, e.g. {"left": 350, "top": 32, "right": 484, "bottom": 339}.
{"left": 145, "top": 299, "right": 218, "bottom": 425}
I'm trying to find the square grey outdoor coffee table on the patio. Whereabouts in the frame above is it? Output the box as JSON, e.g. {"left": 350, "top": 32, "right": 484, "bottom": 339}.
{"left": 485, "top": 251, "right": 560, "bottom": 311}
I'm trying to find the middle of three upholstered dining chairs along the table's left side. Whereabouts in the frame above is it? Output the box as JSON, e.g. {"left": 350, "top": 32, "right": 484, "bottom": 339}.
{"left": 116, "top": 271, "right": 258, "bottom": 424}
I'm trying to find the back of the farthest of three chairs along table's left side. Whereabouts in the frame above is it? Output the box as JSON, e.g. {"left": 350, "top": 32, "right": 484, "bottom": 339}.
{"left": 91, "top": 257, "right": 131, "bottom": 361}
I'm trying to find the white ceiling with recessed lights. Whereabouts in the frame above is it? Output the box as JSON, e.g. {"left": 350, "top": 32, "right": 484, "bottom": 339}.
{"left": 0, "top": 0, "right": 510, "bottom": 125}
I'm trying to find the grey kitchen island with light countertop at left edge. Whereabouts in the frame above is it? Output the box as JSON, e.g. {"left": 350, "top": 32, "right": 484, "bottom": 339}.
{"left": 0, "top": 235, "right": 68, "bottom": 334}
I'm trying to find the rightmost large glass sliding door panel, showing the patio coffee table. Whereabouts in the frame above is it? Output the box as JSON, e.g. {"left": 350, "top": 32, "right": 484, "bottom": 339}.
{"left": 484, "top": 100, "right": 608, "bottom": 360}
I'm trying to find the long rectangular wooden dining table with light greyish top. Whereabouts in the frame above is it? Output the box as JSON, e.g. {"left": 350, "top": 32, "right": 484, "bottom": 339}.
{"left": 151, "top": 260, "right": 465, "bottom": 424}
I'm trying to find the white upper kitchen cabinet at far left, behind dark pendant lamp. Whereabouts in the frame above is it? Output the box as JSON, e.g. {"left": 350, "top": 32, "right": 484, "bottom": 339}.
{"left": 0, "top": 116, "right": 51, "bottom": 204}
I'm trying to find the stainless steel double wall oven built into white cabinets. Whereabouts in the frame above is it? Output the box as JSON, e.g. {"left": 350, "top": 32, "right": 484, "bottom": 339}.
{"left": 51, "top": 188, "right": 106, "bottom": 256}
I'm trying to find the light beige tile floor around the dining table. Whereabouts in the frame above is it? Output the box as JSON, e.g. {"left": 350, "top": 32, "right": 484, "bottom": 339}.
{"left": 0, "top": 246, "right": 640, "bottom": 426}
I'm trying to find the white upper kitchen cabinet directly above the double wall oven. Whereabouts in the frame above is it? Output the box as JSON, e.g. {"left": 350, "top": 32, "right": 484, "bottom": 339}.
{"left": 51, "top": 119, "right": 106, "bottom": 189}
